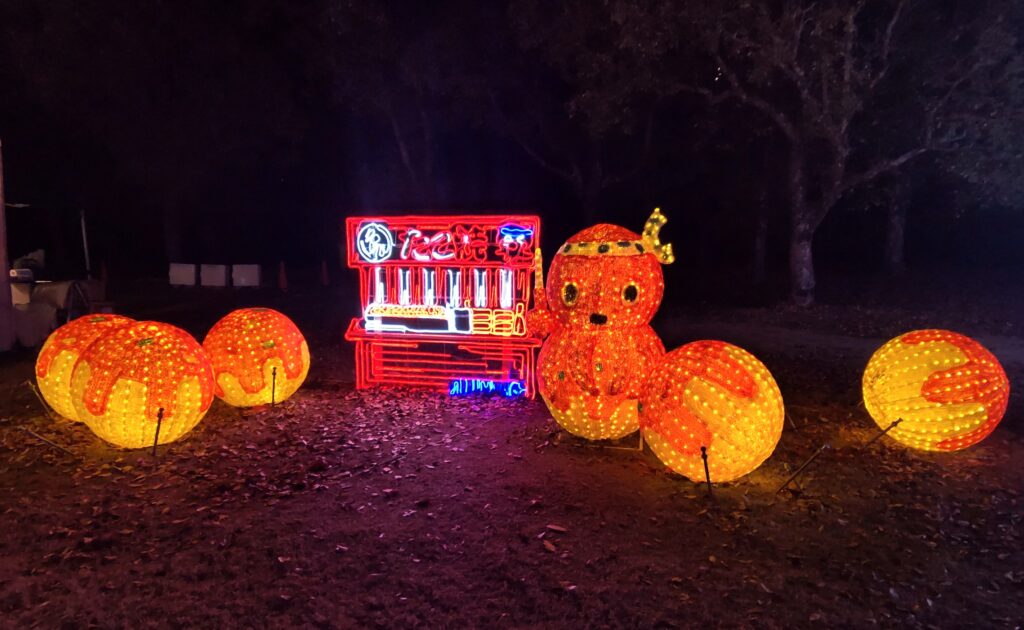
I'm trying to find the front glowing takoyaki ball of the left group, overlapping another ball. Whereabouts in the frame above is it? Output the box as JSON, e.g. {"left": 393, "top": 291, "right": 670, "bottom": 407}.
{"left": 71, "top": 322, "right": 214, "bottom": 449}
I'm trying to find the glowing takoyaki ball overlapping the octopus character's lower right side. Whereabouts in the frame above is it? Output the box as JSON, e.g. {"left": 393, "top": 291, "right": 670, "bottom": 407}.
{"left": 640, "top": 341, "right": 785, "bottom": 481}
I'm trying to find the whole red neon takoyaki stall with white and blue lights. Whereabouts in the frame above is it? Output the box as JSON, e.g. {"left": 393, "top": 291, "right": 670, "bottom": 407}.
{"left": 345, "top": 215, "right": 542, "bottom": 397}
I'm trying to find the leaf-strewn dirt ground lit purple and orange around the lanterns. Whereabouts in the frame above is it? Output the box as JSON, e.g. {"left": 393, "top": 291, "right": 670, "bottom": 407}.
{"left": 0, "top": 282, "right": 1024, "bottom": 628}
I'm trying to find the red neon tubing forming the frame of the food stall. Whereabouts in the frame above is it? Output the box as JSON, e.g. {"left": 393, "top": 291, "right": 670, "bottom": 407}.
{"left": 345, "top": 214, "right": 543, "bottom": 398}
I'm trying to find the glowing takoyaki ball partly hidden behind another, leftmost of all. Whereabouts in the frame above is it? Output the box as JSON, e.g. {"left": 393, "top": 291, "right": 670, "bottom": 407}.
{"left": 36, "top": 314, "right": 134, "bottom": 421}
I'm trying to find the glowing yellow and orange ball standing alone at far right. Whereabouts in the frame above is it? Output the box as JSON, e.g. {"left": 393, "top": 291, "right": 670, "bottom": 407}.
{"left": 863, "top": 330, "right": 1010, "bottom": 451}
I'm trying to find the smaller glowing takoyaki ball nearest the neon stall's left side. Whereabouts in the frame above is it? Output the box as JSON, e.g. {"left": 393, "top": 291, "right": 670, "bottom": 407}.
{"left": 203, "top": 308, "right": 309, "bottom": 407}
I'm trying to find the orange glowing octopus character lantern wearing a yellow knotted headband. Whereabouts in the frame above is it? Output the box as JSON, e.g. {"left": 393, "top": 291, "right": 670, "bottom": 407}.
{"left": 527, "top": 209, "right": 674, "bottom": 439}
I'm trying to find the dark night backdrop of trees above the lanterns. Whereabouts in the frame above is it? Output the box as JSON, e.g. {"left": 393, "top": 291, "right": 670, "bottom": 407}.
{"left": 0, "top": 0, "right": 1024, "bottom": 304}
